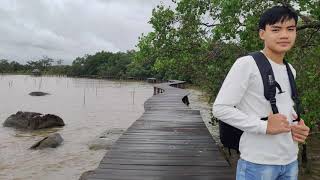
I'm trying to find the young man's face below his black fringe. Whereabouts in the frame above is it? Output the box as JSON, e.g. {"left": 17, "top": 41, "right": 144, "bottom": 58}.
{"left": 259, "top": 19, "right": 296, "bottom": 53}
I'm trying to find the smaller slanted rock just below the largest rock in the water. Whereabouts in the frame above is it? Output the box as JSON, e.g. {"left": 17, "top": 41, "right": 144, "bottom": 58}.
{"left": 30, "top": 133, "right": 63, "bottom": 149}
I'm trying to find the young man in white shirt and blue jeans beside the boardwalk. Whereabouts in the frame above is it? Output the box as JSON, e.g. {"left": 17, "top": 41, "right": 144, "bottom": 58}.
{"left": 213, "top": 6, "right": 309, "bottom": 180}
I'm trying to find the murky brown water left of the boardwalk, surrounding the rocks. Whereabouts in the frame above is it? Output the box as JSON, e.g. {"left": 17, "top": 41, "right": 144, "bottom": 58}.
{"left": 0, "top": 75, "right": 153, "bottom": 180}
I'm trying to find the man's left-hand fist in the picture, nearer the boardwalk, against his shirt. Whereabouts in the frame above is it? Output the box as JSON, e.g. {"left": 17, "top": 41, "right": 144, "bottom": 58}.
{"left": 267, "top": 113, "right": 291, "bottom": 135}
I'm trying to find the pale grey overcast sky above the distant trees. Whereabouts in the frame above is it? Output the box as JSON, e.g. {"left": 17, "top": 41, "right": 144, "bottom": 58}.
{"left": 0, "top": 0, "right": 171, "bottom": 64}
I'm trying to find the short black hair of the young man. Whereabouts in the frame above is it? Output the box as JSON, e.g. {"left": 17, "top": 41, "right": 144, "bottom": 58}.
{"left": 259, "top": 6, "right": 298, "bottom": 30}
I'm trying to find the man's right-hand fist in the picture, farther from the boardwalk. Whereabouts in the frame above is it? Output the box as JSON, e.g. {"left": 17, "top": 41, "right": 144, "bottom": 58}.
{"left": 291, "top": 119, "right": 310, "bottom": 143}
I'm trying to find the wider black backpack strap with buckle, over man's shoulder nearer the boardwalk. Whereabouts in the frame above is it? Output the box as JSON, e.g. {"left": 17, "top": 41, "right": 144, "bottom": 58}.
{"left": 250, "top": 52, "right": 282, "bottom": 114}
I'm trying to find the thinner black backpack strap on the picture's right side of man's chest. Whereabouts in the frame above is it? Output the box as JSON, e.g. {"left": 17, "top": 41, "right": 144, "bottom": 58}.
{"left": 283, "top": 60, "right": 301, "bottom": 122}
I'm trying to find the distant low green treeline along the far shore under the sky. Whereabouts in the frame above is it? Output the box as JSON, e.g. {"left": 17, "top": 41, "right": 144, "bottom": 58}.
{"left": 0, "top": 51, "right": 151, "bottom": 79}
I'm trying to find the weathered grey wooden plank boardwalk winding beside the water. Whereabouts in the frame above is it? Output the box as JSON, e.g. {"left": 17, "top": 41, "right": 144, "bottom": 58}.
{"left": 88, "top": 81, "right": 235, "bottom": 180}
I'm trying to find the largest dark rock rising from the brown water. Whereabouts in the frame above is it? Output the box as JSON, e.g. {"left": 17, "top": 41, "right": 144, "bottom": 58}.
{"left": 3, "top": 111, "right": 64, "bottom": 130}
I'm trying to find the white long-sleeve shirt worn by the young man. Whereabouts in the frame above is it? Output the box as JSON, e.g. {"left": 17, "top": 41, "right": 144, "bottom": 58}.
{"left": 212, "top": 56, "right": 298, "bottom": 165}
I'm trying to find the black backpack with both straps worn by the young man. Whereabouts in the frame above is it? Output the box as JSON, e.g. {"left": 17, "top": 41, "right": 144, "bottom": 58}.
{"left": 219, "top": 52, "right": 300, "bottom": 153}
